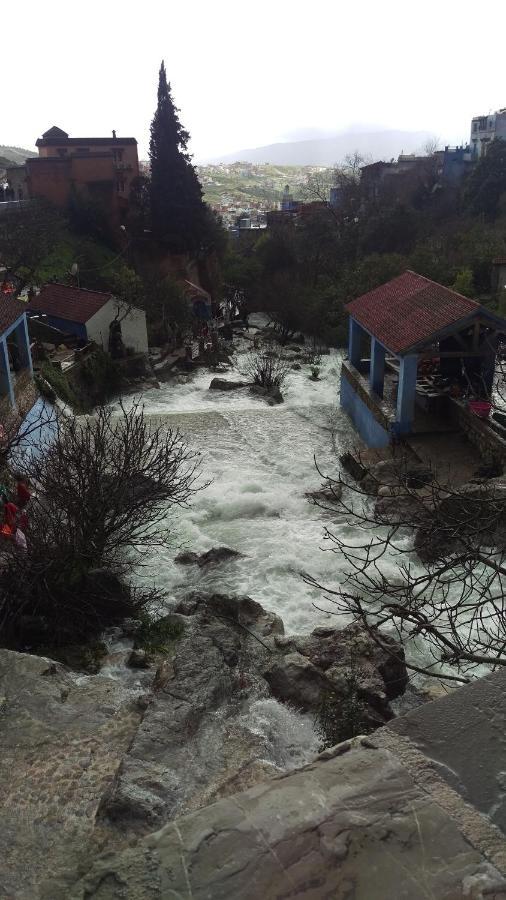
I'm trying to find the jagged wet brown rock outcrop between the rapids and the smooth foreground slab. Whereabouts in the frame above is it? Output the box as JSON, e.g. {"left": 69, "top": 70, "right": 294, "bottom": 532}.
{"left": 98, "top": 592, "right": 406, "bottom": 832}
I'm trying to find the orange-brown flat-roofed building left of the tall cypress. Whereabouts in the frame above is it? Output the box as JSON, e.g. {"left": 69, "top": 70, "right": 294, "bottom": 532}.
{"left": 8, "top": 126, "right": 139, "bottom": 225}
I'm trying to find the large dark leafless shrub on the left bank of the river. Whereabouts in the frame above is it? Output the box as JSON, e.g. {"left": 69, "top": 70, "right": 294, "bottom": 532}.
{"left": 0, "top": 404, "right": 206, "bottom": 645}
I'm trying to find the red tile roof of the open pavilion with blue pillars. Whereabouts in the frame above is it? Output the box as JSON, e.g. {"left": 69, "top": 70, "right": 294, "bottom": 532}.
{"left": 346, "top": 271, "right": 480, "bottom": 353}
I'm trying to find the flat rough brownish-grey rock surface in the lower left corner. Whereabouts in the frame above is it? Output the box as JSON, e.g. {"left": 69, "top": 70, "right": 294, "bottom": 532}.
{"left": 0, "top": 650, "right": 147, "bottom": 900}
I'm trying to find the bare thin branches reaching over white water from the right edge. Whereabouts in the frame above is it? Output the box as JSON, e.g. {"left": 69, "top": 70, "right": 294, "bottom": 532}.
{"left": 305, "top": 459, "right": 506, "bottom": 681}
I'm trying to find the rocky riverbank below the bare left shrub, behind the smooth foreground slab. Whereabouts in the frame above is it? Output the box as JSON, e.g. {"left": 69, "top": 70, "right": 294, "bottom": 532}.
{"left": 0, "top": 592, "right": 406, "bottom": 900}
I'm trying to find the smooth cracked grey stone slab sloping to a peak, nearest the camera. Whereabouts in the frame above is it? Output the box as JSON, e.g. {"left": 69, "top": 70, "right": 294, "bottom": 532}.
{"left": 68, "top": 743, "right": 506, "bottom": 900}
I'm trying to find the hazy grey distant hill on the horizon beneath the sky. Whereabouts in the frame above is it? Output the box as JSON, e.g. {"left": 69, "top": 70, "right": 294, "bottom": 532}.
{"left": 208, "top": 131, "right": 434, "bottom": 166}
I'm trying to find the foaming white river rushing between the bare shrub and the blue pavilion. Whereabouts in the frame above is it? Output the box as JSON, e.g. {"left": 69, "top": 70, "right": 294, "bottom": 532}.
{"left": 115, "top": 317, "right": 368, "bottom": 632}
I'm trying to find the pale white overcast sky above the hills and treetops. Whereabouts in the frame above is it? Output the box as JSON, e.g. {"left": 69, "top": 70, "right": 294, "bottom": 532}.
{"left": 4, "top": 0, "right": 506, "bottom": 162}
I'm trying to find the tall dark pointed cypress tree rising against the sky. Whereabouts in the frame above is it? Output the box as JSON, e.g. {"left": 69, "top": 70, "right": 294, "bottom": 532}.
{"left": 149, "top": 61, "right": 206, "bottom": 252}
